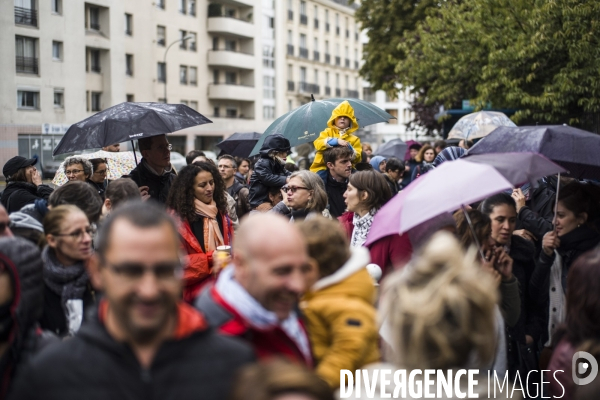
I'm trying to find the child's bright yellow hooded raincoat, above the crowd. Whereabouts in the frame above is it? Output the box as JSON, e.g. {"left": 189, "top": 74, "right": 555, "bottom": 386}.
{"left": 310, "top": 100, "right": 362, "bottom": 173}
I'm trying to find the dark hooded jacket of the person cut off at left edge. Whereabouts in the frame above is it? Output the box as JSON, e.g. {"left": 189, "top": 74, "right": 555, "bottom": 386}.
{"left": 0, "top": 238, "right": 58, "bottom": 399}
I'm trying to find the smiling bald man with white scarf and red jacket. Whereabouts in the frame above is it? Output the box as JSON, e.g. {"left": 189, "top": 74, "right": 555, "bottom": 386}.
{"left": 195, "top": 214, "right": 313, "bottom": 367}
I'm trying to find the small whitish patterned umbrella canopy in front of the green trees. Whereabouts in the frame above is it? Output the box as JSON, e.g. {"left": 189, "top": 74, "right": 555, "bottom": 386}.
{"left": 448, "top": 111, "right": 516, "bottom": 139}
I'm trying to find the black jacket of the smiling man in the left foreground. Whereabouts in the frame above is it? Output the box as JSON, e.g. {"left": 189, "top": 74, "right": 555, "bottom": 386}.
{"left": 9, "top": 304, "right": 255, "bottom": 400}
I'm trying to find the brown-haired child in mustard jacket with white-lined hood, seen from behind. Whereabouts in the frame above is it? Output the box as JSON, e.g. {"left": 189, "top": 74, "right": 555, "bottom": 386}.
{"left": 298, "top": 217, "right": 380, "bottom": 388}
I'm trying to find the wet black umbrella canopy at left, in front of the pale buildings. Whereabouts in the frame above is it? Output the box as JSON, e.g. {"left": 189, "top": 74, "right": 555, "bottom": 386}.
{"left": 52, "top": 103, "right": 212, "bottom": 155}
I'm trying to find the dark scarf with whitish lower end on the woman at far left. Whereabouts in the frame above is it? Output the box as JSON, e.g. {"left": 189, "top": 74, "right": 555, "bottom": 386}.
{"left": 42, "top": 246, "right": 89, "bottom": 335}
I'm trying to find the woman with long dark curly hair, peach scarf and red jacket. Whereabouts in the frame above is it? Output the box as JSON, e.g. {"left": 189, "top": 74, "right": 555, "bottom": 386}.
{"left": 167, "top": 162, "right": 233, "bottom": 302}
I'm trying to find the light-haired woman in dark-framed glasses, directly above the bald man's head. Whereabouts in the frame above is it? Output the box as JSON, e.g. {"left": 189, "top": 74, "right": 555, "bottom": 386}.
{"left": 271, "top": 170, "right": 331, "bottom": 222}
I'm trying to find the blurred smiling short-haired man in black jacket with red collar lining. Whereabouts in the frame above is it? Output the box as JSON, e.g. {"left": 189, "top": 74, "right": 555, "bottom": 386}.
{"left": 9, "top": 202, "right": 254, "bottom": 400}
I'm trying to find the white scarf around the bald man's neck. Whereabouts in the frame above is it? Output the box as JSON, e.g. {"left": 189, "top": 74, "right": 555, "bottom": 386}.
{"left": 215, "top": 265, "right": 311, "bottom": 360}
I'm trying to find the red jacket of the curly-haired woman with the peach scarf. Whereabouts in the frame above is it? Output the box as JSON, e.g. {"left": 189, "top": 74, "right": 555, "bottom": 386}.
{"left": 179, "top": 213, "right": 233, "bottom": 303}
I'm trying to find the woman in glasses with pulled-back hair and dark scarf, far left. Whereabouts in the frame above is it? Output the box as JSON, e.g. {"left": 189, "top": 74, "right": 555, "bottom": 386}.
{"left": 40, "top": 205, "right": 95, "bottom": 337}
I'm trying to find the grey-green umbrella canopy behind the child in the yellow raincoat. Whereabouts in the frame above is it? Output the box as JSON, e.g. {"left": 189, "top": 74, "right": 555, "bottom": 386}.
{"left": 250, "top": 98, "right": 396, "bottom": 156}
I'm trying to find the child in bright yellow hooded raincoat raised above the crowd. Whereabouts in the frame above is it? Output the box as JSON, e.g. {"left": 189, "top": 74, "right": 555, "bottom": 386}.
{"left": 310, "top": 100, "right": 362, "bottom": 176}
